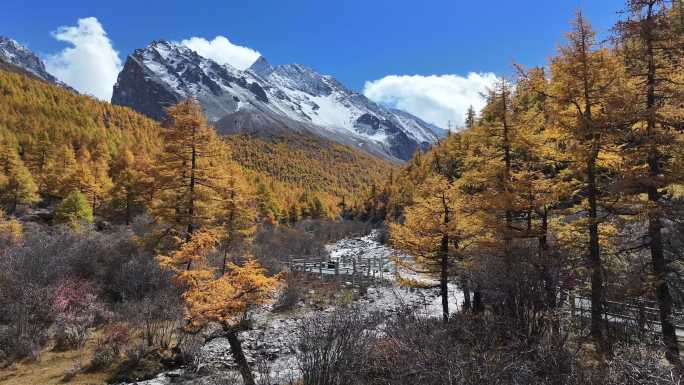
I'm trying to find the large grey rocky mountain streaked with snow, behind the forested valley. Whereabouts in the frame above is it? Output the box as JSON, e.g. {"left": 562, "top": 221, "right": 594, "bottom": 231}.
{"left": 112, "top": 41, "right": 444, "bottom": 160}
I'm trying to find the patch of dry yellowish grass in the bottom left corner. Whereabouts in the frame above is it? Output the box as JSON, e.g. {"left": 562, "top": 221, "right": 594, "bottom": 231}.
{"left": 0, "top": 334, "right": 111, "bottom": 385}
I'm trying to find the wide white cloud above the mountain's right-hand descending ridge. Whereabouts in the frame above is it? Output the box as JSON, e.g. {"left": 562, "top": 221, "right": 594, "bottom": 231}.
{"left": 363, "top": 72, "right": 497, "bottom": 128}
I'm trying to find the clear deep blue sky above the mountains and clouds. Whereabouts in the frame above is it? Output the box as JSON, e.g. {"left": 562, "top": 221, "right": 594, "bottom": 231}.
{"left": 0, "top": 0, "right": 624, "bottom": 127}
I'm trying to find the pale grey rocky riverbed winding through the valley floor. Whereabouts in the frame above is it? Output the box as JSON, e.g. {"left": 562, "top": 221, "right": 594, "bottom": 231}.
{"left": 125, "top": 233, "right": 463, "bottom": 385}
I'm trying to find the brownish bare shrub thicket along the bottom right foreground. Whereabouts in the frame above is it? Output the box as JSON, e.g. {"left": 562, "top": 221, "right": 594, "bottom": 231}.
{"left": 297, "top": 309, "right": 681, "bottom": 385}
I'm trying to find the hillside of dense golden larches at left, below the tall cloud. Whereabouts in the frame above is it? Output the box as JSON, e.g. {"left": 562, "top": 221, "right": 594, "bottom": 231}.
{"left": 0, "top": 67, "right": 160, "bottom": 216}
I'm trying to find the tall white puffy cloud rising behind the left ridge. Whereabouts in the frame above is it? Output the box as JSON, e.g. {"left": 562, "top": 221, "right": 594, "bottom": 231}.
{"left": 45, "top": 17, "right": 121, "bottom": 100}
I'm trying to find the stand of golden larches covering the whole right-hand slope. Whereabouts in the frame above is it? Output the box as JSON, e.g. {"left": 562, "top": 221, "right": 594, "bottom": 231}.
{"left": 384, "top": 0, "right": 684, "bottom": 367}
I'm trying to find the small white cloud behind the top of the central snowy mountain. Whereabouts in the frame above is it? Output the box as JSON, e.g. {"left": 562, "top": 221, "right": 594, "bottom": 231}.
{"left": 181, "top": 36, "right": 261, "bottom": 70}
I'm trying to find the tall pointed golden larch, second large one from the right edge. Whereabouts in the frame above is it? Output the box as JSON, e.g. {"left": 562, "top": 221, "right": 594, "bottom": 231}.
{"left": 549, "top": 12, "right": 625, "bottom": 351}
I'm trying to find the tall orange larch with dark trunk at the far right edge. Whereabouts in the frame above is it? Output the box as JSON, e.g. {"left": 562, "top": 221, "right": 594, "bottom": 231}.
{"left": 615, "top": 0, "right": 684, "bottom": 368}
